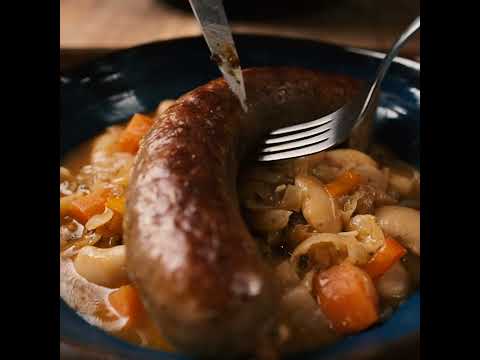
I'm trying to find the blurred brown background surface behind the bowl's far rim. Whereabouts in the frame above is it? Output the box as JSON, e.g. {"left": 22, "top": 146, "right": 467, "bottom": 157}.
{"left": 60, "top": 0, "right": 420, "bottom": 69}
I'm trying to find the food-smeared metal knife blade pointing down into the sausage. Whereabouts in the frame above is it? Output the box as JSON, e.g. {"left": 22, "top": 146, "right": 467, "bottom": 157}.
{"left": 189, "top": 0, "right": 247, "bottom": 111}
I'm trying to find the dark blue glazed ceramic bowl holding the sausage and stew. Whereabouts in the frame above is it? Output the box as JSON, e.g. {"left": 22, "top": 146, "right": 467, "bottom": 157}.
{"left": 60, "top": 35, "right": 420, "bottom": 360}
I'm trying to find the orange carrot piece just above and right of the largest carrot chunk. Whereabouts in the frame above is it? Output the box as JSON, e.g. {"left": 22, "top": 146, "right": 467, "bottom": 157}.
{"left": 363, "top": 236, "right": 407, "bottom": 280}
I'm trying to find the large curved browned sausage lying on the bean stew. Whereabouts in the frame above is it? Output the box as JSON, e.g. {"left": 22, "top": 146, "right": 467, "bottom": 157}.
{"left": 124, "top": 68, "right": 358, "bottom": 356}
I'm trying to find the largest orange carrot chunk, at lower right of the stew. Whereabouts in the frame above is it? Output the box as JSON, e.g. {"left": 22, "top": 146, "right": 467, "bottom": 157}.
{"left": 313, "top": 262, "right": 378, "bottom": 334}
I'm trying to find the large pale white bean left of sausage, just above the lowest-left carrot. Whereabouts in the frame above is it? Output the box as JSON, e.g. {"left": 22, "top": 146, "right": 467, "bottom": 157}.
{"left": 74, "top": 245, "right": 129, "bottom": 288}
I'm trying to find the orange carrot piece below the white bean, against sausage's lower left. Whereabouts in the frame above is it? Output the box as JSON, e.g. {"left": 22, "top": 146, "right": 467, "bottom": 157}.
{"left": 108, "top": 285, "right": 145, "bottom": 327}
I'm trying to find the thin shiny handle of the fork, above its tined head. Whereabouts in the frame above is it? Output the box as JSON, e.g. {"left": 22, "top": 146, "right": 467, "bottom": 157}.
{"left": 359, "top": 16, "right": 420, "bottom": 119}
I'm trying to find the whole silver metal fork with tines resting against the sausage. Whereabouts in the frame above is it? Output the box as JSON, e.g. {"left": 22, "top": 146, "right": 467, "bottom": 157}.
{"left": 258, "top": 17, "right": 420, "bottom": 161}
